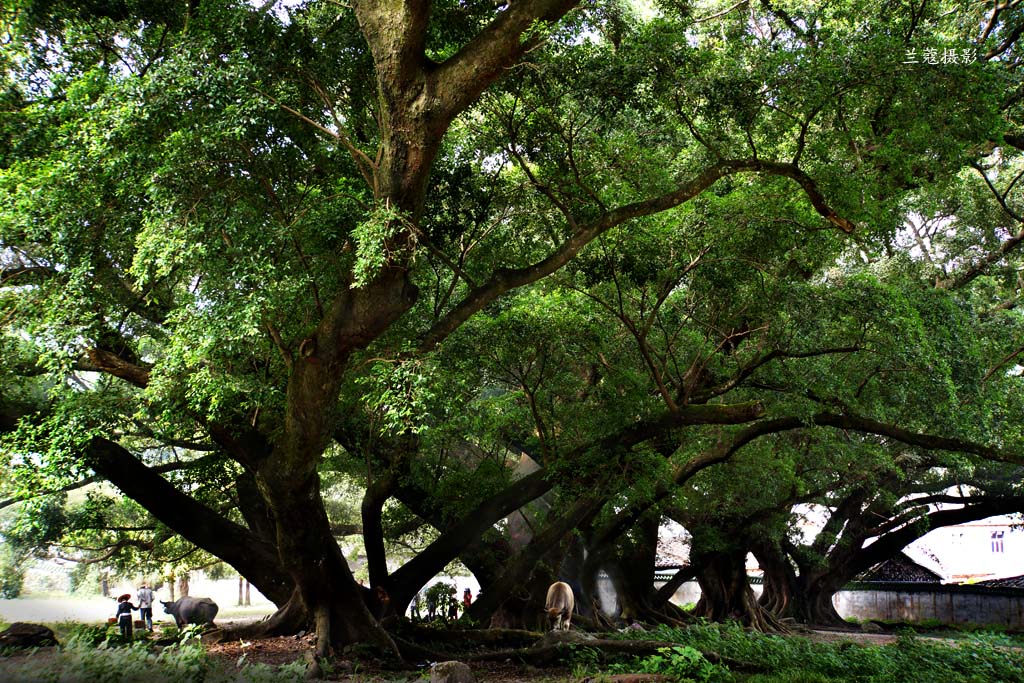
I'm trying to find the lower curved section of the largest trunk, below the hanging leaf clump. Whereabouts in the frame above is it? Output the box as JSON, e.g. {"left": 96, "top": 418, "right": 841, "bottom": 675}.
{"left": 256, "top": 255, "right": 416, "bottom": 654}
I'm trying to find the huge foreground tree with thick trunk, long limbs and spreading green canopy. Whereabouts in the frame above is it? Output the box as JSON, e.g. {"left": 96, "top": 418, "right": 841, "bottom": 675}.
{"left": 0, "top": 0, "right": 1024, "bottom": 648}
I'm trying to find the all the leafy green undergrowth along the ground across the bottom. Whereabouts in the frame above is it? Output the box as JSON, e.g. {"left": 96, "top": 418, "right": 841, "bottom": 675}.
{"left": 0, "top": 623, "right": 1024, "bottom": 683}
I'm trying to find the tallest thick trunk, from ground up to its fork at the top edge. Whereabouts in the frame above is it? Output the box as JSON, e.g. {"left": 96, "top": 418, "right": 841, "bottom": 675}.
{"left": 223, "top": 0, "right": 575, "bottom": 651}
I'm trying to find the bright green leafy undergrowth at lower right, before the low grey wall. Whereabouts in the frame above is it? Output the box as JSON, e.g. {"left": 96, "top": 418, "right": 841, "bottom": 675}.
{"left": 577, "top": 623, "right": 1024, "bottom": 683}
